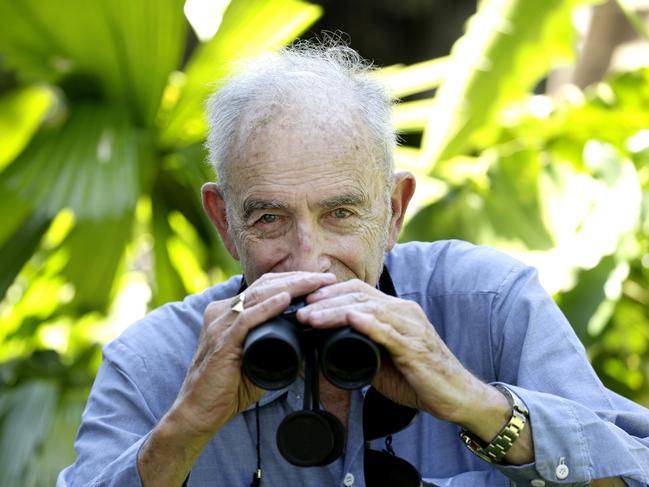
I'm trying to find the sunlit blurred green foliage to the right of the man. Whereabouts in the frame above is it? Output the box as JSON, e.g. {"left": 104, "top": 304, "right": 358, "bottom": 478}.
{"left": 389, "top": 1, "right": 649, "bottom": 404}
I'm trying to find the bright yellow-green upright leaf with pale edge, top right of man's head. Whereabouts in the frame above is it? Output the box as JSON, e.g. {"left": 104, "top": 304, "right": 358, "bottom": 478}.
{"left": 422, "top": 0, "right": 591, "bottom": 163}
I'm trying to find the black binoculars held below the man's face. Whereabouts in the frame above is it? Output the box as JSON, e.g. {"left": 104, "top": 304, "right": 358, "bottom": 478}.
{"left": 242, "top": 297, "right": 381, "bottom": 390}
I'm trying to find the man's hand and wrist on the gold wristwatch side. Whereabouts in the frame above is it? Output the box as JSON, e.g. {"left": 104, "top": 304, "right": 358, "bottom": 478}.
{"left": 297, "top": 280, "right": 534, "bottom": 464}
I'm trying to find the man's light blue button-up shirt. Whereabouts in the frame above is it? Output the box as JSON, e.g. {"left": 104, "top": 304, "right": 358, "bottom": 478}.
{"left": 57, "top": 241, "right": 649, "bottom": 487}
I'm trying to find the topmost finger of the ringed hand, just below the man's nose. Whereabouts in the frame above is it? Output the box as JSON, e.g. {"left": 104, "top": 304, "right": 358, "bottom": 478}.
{"left": 244, "top": 272, "right": 336, "bottom": 308}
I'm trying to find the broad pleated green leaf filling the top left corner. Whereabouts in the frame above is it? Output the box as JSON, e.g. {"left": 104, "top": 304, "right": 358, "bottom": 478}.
{"left": 0, "top": 0, "right": 187, "bottom": 125}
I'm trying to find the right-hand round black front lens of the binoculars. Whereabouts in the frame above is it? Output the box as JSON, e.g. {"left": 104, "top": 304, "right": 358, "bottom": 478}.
{"left": 320, "top": 328, "right": 381, "bottom": 389}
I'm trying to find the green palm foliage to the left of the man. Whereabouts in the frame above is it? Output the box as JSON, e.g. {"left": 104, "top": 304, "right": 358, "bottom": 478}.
{"left": 0, "top": 0, "right": 320, "bottom": 486}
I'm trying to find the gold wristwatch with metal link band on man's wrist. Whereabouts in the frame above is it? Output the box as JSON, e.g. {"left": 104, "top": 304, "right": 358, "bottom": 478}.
{"left": 460, "top": 384, "right": 529, "bottom": 463}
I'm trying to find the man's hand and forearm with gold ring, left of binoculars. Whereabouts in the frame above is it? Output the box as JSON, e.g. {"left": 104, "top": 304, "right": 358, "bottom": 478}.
{"left": 138, "top": 272, "right": 336, "bottom": 487}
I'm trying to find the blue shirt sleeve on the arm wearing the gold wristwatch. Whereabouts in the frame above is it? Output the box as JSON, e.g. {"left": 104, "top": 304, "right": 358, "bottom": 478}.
{"left": 486, "top": 268, "right": 649, "bottom": 487}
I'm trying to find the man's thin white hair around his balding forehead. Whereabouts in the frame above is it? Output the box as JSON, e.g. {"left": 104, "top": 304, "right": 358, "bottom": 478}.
{"left": 206, "top": 42, "right": 396, "bottom": 196}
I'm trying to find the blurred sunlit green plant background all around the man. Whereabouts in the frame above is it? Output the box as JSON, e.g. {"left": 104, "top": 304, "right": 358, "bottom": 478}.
{"left": 0, "top": 0, "right": 649, "bottom": 487}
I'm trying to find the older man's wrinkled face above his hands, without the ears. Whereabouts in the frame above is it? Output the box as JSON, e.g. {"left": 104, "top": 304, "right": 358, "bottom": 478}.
{"left": 220, "top": 103, "right": 390, "bottom": 285}
